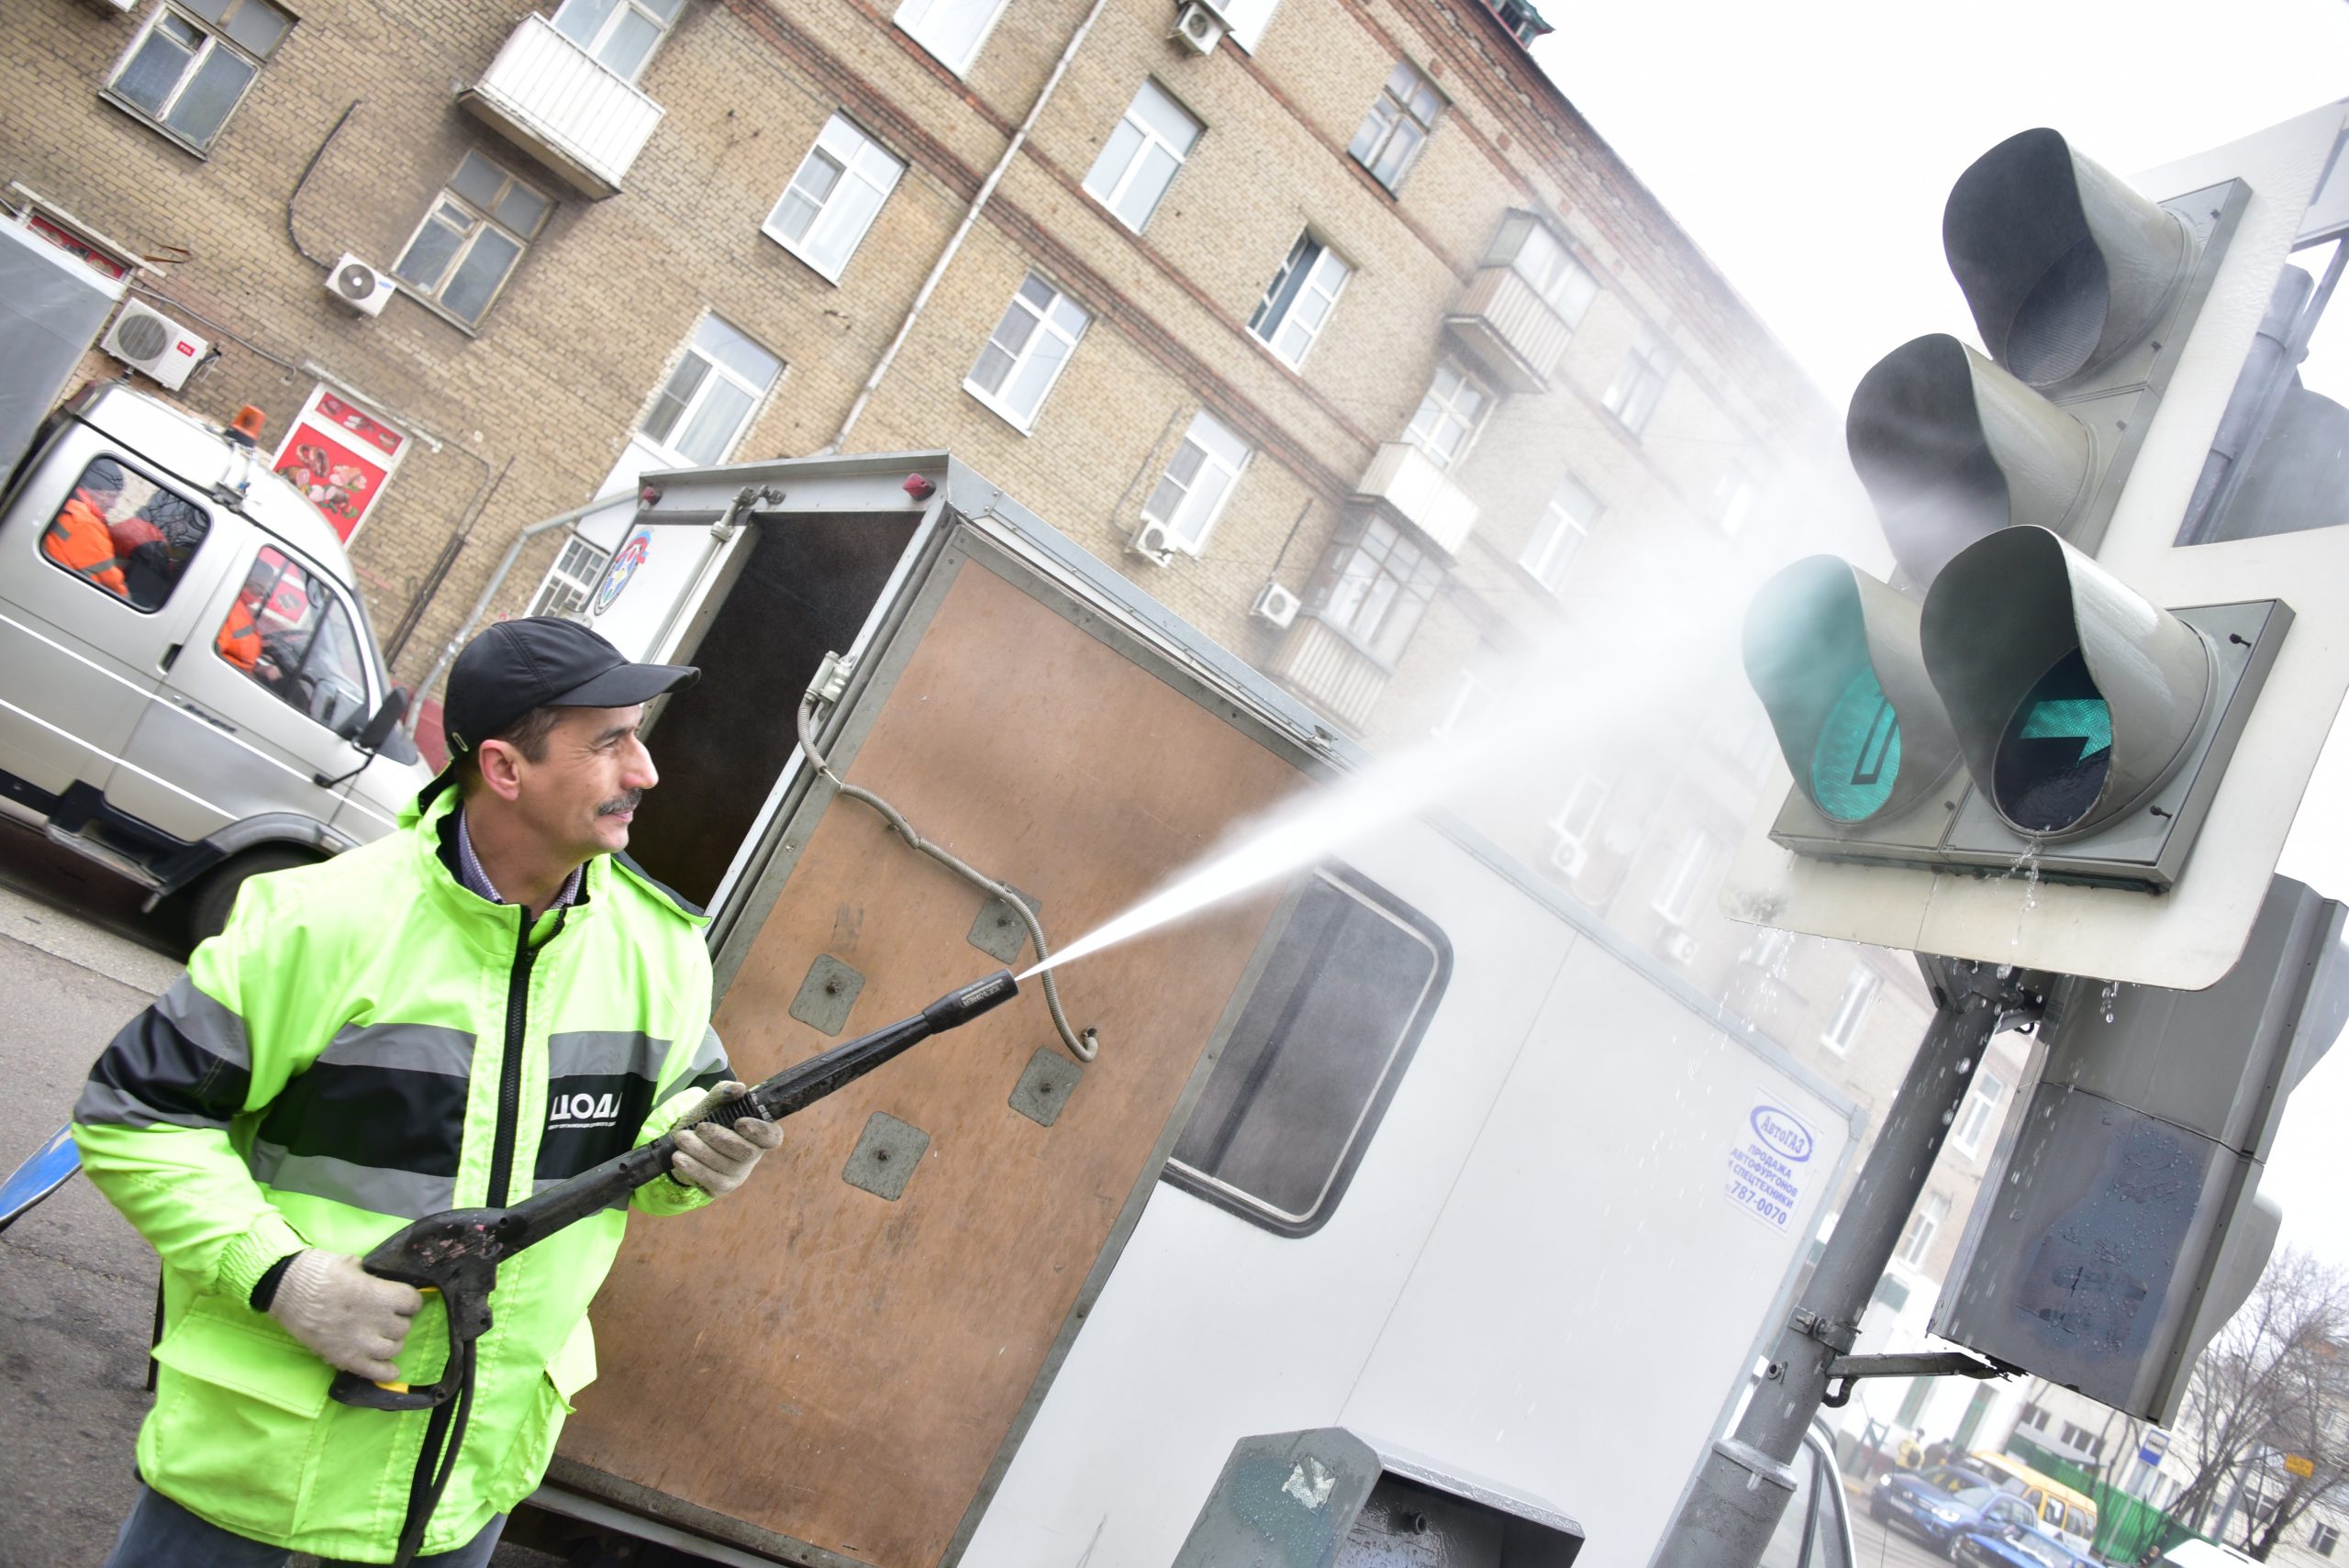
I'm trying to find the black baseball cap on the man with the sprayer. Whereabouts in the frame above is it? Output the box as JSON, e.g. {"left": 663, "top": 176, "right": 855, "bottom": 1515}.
{"left": 441, "top": 615, "right": 702, "bottom": 758}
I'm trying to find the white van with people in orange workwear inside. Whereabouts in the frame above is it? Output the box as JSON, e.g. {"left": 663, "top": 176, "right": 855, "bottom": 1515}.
{"left": 0, "top": 387, "right": 429, "bottom": 937}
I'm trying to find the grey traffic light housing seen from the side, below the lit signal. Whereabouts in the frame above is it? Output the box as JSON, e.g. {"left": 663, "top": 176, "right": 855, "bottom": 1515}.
{"left": 1933, "top": 878, "right": 2349, "bottom": 1422}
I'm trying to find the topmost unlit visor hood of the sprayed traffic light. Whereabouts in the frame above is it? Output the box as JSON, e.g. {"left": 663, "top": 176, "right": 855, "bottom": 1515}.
{"left": 1941, "top": 129, "right": 2197, "bottom": 387}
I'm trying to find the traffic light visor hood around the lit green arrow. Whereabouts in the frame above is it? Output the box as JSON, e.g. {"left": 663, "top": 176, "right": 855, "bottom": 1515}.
{"left": 1921, "top": 528, "right": 2215, "bottom": 838}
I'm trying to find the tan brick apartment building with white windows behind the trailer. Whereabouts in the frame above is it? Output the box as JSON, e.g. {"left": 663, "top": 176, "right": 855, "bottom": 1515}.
{"left": 0, "top": 0, "right": 2013, "bottom": 1408}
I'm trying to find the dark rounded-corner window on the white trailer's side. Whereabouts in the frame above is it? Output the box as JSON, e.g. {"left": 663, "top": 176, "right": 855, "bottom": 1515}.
{"left": 1167, "top": 869, "right": 1452, "bottom": 1235}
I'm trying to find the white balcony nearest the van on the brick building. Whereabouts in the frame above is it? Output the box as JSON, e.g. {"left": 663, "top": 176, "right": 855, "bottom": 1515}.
{"left": 456, "top": 14, "right": 660, "bottom": 202}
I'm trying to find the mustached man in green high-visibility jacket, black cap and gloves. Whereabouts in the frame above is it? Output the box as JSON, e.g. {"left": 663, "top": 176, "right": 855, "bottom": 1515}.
{"left": 72, "top": 617, "right": 782, "bottom": 1568}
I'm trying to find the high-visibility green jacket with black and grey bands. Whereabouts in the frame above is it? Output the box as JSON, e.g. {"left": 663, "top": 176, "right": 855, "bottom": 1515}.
{"left": 72, "top": 791, "right": 729, "bottom": 1563}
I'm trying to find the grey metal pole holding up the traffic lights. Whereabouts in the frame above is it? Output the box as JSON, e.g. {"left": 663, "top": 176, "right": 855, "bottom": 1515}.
{"left": 1652, "top": 955, "right": 2046, "bottom": 1568}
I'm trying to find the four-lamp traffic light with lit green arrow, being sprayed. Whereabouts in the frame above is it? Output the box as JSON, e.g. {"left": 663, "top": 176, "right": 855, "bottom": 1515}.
{"left": 1745, "top": 129, "right": 2293, "bottom": 892}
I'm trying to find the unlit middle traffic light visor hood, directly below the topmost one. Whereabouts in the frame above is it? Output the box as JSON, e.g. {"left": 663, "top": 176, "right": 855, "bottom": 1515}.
{"left": 1844, "top": 333, "right": 2093, "bottom": 584}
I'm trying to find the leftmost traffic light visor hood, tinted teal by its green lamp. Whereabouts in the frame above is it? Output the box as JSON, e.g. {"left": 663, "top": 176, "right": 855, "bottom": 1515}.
{"left": 1745, "top": 556, "right": 1956, "bottom": 827}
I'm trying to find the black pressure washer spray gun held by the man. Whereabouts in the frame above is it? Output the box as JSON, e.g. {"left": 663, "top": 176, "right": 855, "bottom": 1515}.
{"left": 334, "top": 970, "right": 1019, "bottom": 1563}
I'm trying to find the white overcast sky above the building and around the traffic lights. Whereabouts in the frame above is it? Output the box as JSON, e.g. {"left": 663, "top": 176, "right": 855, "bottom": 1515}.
{"left": 1534, "top": 15, "right": 2349, "bottom": 1268}
